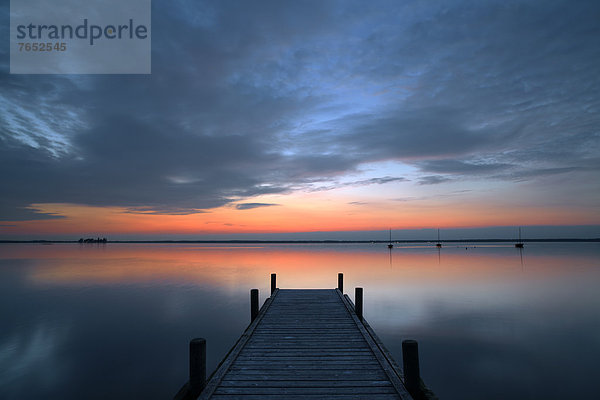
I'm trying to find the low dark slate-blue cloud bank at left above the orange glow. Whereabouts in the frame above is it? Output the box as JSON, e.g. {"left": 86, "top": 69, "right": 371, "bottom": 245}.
{"left": 0, "top": 112, "right": 283, "bottom": 217}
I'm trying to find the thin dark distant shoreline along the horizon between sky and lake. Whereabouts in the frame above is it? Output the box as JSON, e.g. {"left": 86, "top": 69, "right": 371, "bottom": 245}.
{"left": 0, "top": 238, "right": 600, "bottom": 245}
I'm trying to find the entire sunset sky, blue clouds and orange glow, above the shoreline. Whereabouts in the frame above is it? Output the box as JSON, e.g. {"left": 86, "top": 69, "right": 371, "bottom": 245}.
{"left": 0, "top": 0, "right": 600, "bottom": 239}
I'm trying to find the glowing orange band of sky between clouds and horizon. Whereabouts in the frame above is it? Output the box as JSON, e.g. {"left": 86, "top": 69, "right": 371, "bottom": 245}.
{"left": 0, "top": 194, "right": 600, "bottom": 237}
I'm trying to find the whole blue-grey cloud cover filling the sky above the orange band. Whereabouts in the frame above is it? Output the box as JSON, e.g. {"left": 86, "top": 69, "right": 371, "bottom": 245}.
{"left": 0, "top": 0, "right": 600, "bottom": 220}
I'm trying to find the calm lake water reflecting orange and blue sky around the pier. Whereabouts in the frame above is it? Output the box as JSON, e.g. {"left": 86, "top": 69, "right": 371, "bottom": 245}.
{"left": 0, "top": 243, "right": 600, "bottom": 400}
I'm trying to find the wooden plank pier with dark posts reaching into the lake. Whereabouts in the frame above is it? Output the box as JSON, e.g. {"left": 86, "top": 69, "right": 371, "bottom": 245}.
{"left": 175, "top": 274, "right": 435, "bottom": 400}
